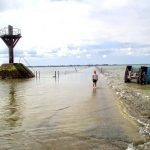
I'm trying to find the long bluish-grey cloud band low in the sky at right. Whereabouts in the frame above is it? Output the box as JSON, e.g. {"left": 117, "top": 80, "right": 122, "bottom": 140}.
{"left": 68, "top": 41, "right": 150, "bottom": 56}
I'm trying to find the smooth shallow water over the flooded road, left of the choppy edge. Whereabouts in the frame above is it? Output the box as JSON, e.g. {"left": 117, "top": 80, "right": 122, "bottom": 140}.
{"left": 0, "top": 68, "right": 144, "bottom": 150}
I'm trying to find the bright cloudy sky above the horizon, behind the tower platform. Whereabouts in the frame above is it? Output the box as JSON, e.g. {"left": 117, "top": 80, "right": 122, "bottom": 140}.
{"left": 0, "top": 0, "right": 150, "bottom": 65}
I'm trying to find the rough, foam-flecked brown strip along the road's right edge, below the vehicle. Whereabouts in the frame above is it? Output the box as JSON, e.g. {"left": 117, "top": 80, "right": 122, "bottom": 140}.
{"left": 97, "top": 68, "right": 150, "bottom": 150}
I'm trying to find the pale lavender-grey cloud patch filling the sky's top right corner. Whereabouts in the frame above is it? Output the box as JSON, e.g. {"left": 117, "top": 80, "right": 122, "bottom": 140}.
{"left": 91, "top": 0, "right": 150, "bottom": 35}
